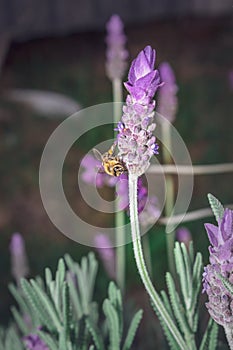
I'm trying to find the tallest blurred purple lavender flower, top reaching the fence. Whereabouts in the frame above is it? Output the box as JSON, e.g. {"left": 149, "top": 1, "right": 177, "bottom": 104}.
{"left": 106, "top": 15, "right": 128, "bottom": 80}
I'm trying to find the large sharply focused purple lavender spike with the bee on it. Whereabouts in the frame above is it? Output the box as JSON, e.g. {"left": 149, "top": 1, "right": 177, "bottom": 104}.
{"left": 118, "top": 46, "right": 162, "bottom": 177}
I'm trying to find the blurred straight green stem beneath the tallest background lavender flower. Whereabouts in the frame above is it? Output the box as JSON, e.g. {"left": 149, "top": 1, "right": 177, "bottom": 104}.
{"left": 112, "top": 79, "right": 125, "bottom": 293}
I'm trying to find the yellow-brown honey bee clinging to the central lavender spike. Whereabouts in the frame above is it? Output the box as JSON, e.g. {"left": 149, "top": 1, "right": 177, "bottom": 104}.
{"left": 93, "top": 143, "right": 127, "bottom": 176}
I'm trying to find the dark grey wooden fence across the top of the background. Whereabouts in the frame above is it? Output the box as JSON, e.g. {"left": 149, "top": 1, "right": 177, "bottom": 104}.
{"left": 0, "top": 0, "right": 233, "bottom": 40}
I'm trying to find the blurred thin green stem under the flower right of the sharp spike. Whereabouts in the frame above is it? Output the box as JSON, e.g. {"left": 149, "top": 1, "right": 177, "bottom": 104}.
{"left": 161, "top": 123, "right": 175, "bottom": 276}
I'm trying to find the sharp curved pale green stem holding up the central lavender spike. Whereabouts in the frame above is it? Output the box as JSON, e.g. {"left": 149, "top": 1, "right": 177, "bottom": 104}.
{"left": 129, "top": 173, "right": 187, "bottom": 350}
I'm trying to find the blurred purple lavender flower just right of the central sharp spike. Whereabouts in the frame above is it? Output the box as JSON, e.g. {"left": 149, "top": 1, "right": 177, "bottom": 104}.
{"left": 157, "top": 62, "right": 178, "bottom": 123}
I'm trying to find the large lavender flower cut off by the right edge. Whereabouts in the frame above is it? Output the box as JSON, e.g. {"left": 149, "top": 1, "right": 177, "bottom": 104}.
{"left": 203, "top": 209, "right": 233, "bottom": 328}
